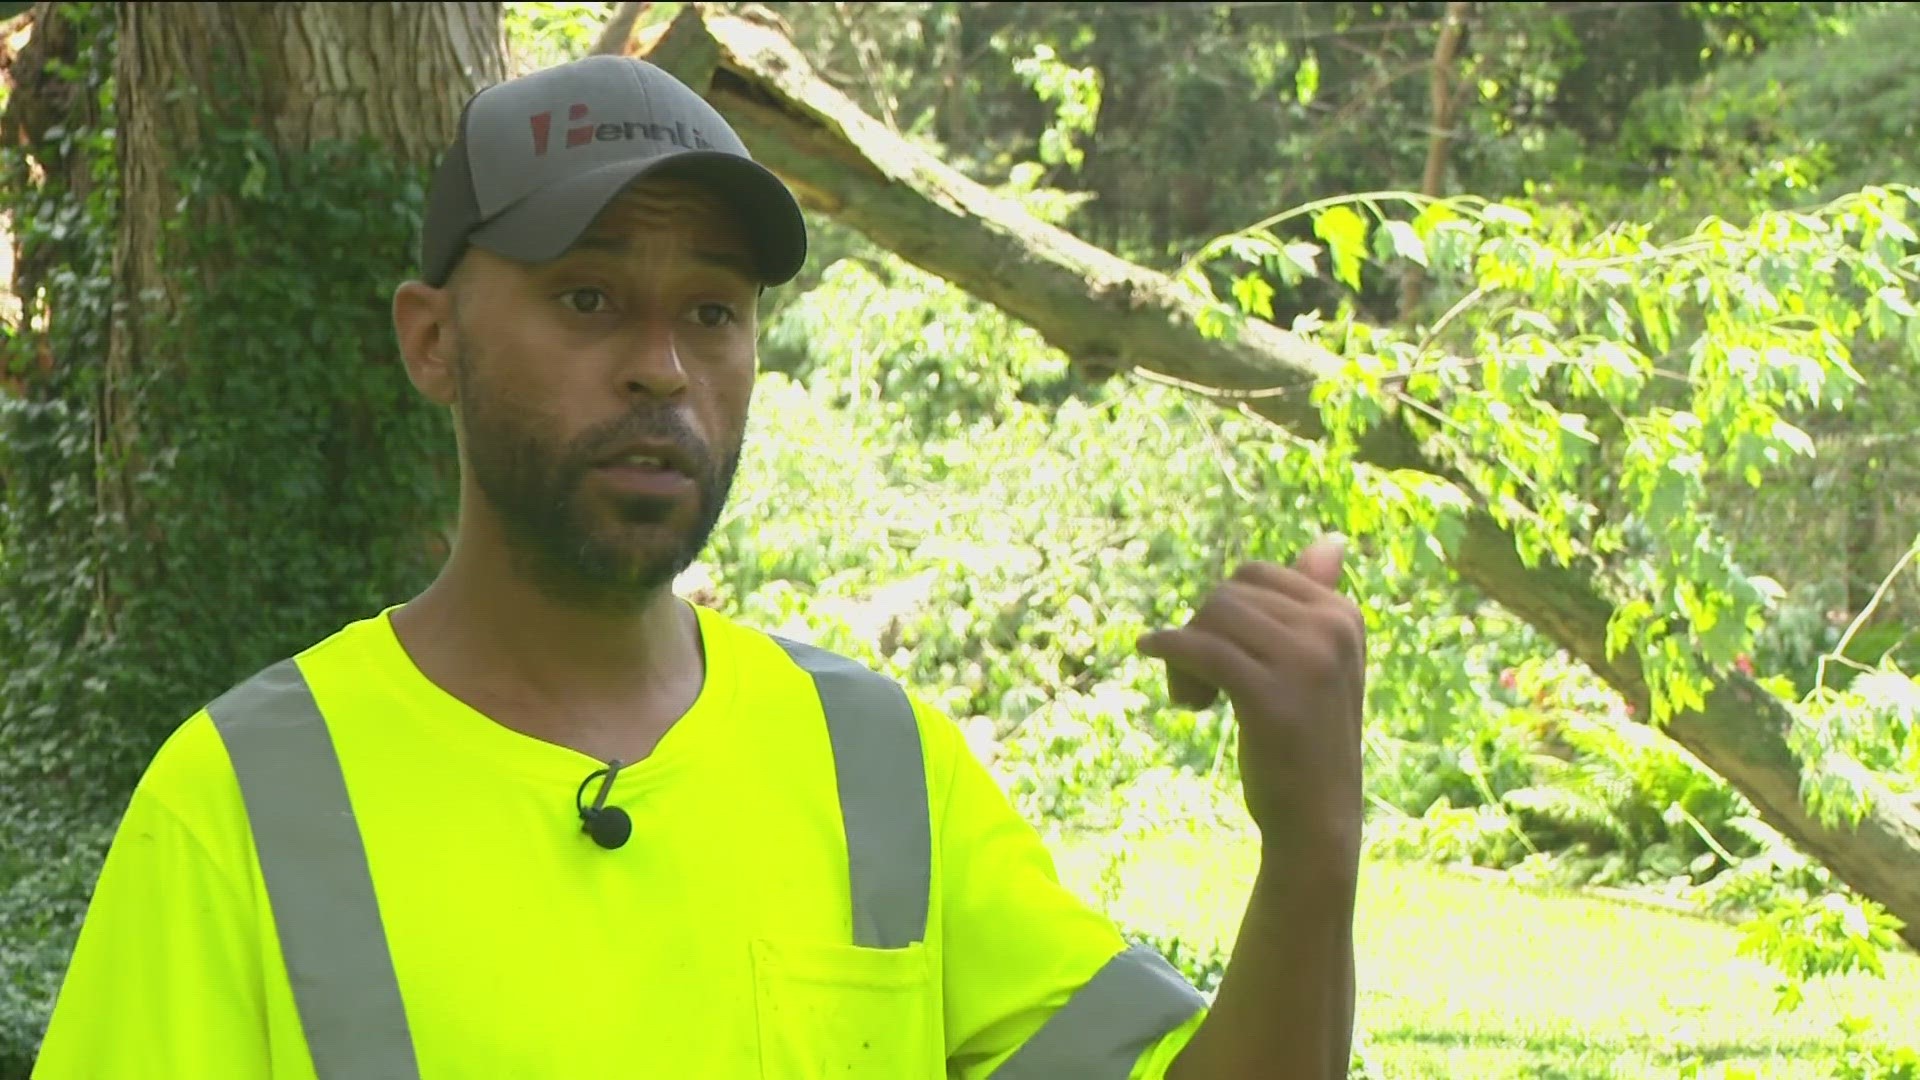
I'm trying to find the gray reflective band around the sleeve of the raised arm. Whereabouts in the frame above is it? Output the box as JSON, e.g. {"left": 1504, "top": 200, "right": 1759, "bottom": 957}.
{"left": 993, "top": 945, "right": 1206, "bottom": 1080}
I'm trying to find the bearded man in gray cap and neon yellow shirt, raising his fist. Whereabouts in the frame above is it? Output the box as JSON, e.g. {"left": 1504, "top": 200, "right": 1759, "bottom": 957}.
{"left": 35, "top": 58, "right": 1363, "bottom": 1080}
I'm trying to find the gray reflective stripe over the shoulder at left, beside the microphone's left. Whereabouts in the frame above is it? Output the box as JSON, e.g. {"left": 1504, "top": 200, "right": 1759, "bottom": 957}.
{"left": 207, "top": 659, "right": 420, "bottom": 1080}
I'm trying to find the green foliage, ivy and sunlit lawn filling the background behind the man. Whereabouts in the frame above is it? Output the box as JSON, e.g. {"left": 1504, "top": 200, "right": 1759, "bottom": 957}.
{"left": 0, "top": 4, "right": 1920, "bottom": 1080}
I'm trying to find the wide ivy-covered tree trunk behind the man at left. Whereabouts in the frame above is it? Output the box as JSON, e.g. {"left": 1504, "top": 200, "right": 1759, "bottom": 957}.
{"left": 0, "top": 4, "right": 505, "bottom": 1074}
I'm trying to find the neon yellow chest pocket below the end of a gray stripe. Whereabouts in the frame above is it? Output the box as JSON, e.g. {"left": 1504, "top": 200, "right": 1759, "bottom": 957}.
{"left": 753, "top": 938, "right": 947, "bottom": 1080}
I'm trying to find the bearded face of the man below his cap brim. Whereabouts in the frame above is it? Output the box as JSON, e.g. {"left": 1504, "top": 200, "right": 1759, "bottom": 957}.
{"left": 441, "top": 171, "right": 758, "bottom": 607}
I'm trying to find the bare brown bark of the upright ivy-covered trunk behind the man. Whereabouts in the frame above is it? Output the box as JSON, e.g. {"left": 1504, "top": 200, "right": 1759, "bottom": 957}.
{"left": 98, "top": 2, "right": 505, "bottom": 626}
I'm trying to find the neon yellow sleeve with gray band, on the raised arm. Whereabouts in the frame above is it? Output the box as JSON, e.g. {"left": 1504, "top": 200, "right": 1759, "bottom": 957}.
{"left": 916, "top": 701, "right": 1206, "bottom": 1080}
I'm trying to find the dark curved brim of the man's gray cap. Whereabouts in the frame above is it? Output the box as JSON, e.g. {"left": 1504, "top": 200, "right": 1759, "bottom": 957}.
{"left": 468, "top": 150, "right": 806, "bottom": 284}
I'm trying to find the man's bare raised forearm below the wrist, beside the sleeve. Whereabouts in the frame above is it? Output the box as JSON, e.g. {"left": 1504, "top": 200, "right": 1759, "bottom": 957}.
{"left": 1167, "top": 844, "right": 1357, "bottom": 1080}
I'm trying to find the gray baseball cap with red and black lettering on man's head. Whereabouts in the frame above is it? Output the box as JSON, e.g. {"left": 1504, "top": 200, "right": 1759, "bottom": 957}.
{"left": 420, "top": 56, "right": 806, "bottom": 288}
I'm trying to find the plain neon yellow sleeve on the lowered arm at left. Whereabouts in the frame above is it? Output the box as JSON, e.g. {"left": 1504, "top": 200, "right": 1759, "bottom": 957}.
{"left": 33, "top": 714, "right": 271, "bottom": 1080}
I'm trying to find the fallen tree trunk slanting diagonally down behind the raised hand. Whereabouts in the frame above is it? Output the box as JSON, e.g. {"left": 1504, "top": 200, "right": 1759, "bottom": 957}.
{"left": 636, "top": 4, "right": 1920, "bottom": 947}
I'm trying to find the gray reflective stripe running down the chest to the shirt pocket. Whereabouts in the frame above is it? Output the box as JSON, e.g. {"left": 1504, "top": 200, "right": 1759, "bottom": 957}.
{"left": 774, "top": 636, "right": 933, "bottom": 949}
